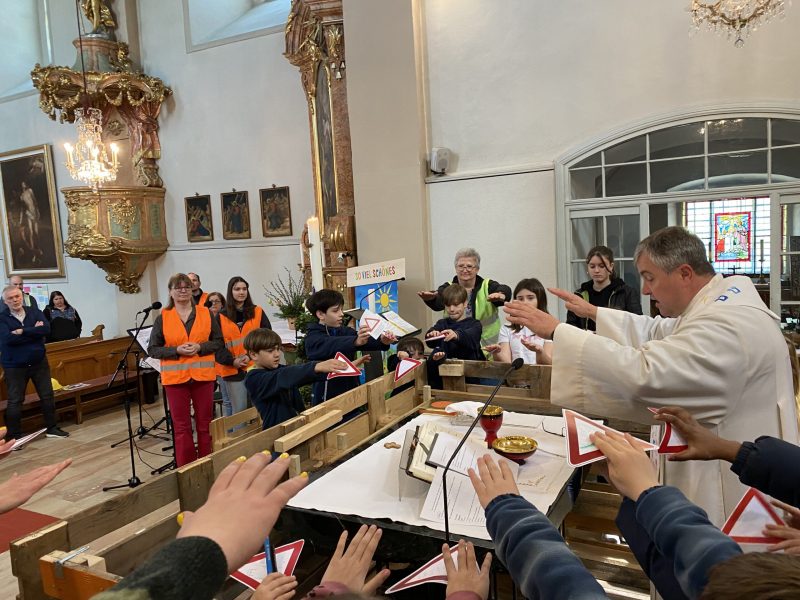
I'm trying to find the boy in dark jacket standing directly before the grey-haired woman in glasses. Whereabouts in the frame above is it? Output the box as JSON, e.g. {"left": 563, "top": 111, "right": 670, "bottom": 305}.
{"left": 425, "top": 283, "right": 486, "bottom": 390}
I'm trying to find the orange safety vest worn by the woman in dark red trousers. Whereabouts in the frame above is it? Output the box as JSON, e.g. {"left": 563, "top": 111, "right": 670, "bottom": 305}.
{"left": 161, "top": 306, "right": 216, "bottom": 385}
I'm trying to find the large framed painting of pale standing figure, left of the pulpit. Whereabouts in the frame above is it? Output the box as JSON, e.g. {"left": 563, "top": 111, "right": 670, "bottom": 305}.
{"left": 0, "top": 144, "right": 64, "bottom": 279}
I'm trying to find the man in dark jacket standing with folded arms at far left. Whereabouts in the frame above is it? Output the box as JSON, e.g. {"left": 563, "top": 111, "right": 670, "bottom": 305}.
{"left": 0, "top": 285, "right": 69, "bottom": 440}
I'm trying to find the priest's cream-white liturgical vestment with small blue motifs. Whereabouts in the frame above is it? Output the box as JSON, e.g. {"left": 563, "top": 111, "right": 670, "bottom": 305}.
{"left": 551, "top": 275, "right": 798, "bottom": 526}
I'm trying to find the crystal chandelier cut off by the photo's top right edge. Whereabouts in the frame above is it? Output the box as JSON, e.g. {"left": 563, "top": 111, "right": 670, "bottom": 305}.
{"left": 690, "top": 0, "right": 784, "bottom": 48}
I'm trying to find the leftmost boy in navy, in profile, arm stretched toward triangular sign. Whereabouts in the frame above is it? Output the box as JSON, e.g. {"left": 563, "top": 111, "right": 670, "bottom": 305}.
{"left": 244, "top": 329, "right": 347, "bottom": 429}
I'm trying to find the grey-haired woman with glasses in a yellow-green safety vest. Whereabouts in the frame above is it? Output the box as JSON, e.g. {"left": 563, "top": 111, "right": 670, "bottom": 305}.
{"left": 418, "top": 248, "right": 511, "bottom": 347}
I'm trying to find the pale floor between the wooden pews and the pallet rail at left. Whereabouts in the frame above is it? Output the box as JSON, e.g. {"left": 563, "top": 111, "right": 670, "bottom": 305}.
{"left": 0, "top": 402, "right": 177, "bottom": 600}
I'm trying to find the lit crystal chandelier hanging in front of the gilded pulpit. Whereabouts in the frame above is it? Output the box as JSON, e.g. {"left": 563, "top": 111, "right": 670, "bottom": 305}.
{"left": 64, "top": 108, "right": 119, "bottom": 190}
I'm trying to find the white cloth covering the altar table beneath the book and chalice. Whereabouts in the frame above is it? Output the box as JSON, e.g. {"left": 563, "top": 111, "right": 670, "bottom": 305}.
{"left": 289, "top": 412, "right": 574, "bottom": 540}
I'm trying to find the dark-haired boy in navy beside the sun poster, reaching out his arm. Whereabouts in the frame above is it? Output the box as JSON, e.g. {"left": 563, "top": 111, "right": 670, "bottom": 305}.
{"left": 305, "top": 289, "right": 397, "bottom": 405}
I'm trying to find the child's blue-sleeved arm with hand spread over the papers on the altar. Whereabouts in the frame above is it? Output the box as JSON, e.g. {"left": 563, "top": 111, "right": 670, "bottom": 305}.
{"left": 469, "top": 456, "right": 607, "bottom": 600}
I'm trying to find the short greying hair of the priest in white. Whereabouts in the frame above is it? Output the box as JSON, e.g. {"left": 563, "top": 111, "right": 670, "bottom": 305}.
{"left": 633, "top": 226, "right": 715, "bottom": 275}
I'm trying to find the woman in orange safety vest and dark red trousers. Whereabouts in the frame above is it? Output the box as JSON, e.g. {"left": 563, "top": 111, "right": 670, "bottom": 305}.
{"left": 147, "top": 273, "right": 222, "bottom": 467}
